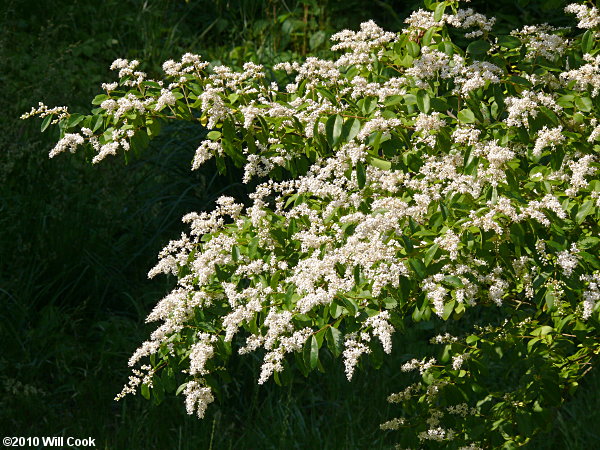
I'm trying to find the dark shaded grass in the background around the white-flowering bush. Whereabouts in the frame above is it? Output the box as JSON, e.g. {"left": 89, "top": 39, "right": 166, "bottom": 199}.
{"left": 0, "top": 0, "right": 600, "bottom": 449}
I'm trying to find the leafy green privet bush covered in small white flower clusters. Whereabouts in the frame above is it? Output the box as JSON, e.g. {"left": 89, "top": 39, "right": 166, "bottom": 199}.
{"left": 25, "top": 0, "right": 600, "bottom": 449}
